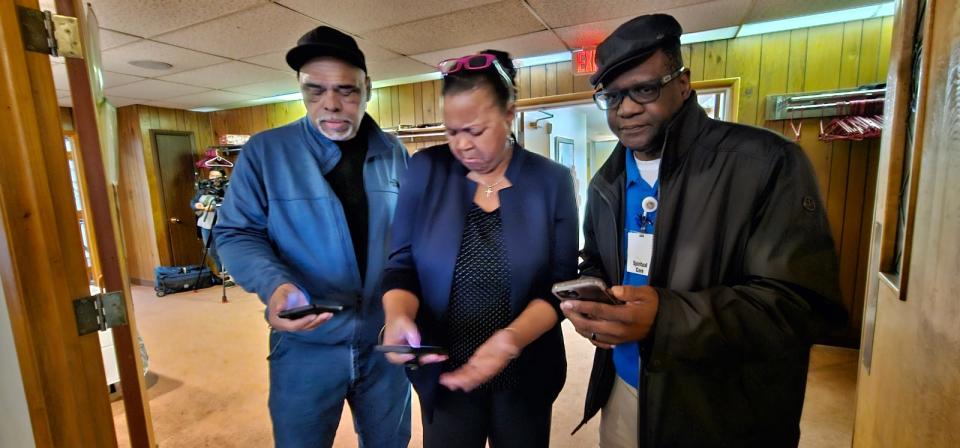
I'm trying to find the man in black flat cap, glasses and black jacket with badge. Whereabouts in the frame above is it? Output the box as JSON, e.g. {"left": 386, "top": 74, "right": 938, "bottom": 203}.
{"left": 561, "top": 14, "right": 845, "bottom": 448}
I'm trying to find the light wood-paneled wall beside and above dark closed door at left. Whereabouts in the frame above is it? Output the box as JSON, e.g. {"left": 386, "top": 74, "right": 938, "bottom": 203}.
{"left": 117, "top": 105, "right": 214, "bottom": 284}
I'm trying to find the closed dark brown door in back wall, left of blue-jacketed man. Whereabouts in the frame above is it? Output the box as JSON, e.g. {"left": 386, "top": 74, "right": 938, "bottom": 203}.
{"left": 151, "top": 131, "right": 203, "bottom": 266}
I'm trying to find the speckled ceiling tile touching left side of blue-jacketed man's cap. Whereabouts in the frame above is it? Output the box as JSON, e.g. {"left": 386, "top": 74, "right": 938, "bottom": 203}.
{"left": 156, "top": 3, "right": 320, "bottom": 59}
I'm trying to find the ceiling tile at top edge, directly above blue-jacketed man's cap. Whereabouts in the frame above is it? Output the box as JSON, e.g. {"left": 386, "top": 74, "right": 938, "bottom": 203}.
{"left": 277, "top": 0, "right": 499, "bottom": 34}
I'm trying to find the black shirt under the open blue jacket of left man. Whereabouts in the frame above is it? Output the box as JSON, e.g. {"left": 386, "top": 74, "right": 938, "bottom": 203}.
{"left": 324, "top": 122, "right": 369, "bottom": 282}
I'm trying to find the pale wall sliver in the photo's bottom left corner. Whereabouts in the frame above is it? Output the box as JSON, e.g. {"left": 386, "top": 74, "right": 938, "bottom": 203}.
{"left": 0, "top": 285, "right": 36, "bottom": 448}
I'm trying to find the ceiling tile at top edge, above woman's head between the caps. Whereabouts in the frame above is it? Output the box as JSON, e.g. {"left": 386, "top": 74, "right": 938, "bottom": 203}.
{"left": 362, "top": 0, "right": 543, "bottom": 54}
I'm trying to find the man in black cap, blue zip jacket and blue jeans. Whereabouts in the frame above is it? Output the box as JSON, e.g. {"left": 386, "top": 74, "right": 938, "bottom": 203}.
{"left": 215, "top": 26, "right": 410, "bottom": 448}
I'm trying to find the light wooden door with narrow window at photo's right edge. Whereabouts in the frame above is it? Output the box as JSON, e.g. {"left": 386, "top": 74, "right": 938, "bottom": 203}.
{"left": 853, "top": 0, "right": 960, "bottom": 448}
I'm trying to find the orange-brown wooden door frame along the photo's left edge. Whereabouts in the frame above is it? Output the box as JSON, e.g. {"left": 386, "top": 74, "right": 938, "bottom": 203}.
{"left": 0, "top": 0, "right": 155, "bottom": 447}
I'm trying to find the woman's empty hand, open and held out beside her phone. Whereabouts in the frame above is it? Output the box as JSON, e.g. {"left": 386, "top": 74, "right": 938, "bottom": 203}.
{"left": 440, "top": 329, "right": 520, "bottom": 392}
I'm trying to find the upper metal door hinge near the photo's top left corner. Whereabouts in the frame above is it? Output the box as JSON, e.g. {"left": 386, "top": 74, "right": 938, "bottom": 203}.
{"left": 17, "top": 6, "right": 83, "bottom": 59}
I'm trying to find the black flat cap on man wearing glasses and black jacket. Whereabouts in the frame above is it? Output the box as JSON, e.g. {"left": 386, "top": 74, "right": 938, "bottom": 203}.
{"left": 590, "top": 14, "right": 683, "bottom": 87}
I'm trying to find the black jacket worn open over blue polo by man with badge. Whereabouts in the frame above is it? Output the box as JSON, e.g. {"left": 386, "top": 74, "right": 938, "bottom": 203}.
{"left": 580, "top": 93, "right": 845, "bottom": 448}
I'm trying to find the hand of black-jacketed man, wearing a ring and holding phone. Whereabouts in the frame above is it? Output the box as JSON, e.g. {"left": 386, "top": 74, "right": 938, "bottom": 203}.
{"left": 560, "top": 286, "right": 660, "bottom": 349}
